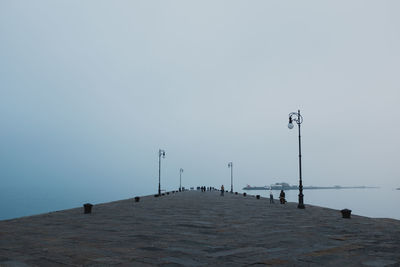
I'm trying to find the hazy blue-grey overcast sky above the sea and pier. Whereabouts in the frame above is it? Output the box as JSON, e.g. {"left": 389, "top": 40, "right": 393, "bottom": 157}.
{"left": 0, "top": 0, "right": 400, "bottom": 205}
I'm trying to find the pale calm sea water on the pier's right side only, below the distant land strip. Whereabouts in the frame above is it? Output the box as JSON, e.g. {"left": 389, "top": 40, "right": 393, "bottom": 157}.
{"left": 241, "top": 188, "right": 400, "bottom": 220}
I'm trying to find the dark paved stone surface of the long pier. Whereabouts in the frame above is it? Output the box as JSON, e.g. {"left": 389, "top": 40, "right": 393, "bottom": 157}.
{"left": 0, "top": 191, "right": 400, "bottom": 266}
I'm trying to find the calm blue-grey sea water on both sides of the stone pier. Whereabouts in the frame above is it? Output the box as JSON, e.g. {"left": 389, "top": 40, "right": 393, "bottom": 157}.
{"left": 0, "top": 188, "right": 400, "bottom": 220}
